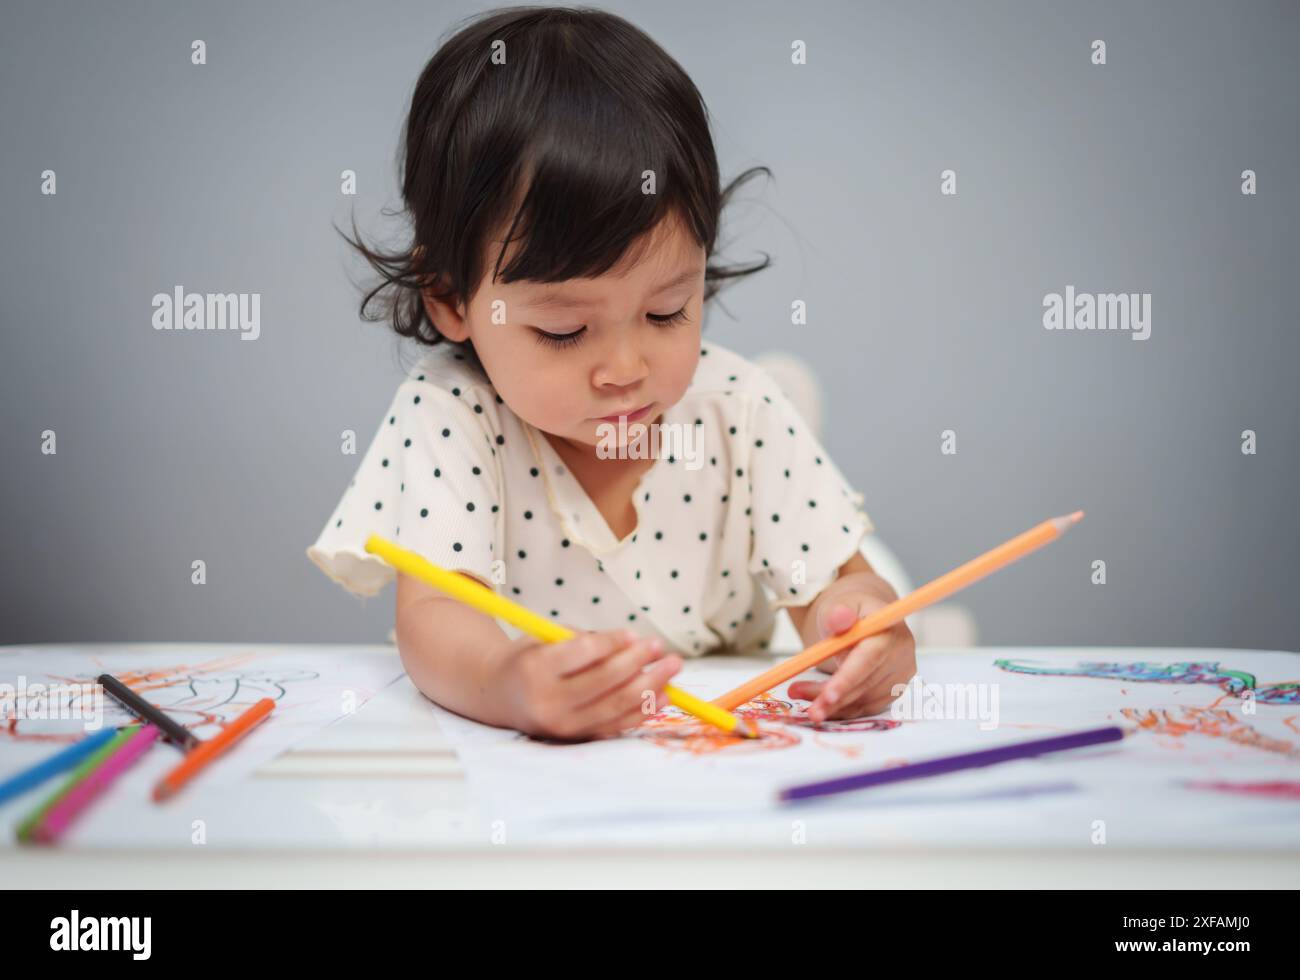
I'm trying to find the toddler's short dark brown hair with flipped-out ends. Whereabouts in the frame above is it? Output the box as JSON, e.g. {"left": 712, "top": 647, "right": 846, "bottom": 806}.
{"left": 335, "top": 6, "right": 771, "bottom": 352}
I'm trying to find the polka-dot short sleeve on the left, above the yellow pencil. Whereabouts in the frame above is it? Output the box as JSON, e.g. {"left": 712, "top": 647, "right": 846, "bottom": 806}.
{"left": 307, "top": 381, "right": 501, "bottom": 595}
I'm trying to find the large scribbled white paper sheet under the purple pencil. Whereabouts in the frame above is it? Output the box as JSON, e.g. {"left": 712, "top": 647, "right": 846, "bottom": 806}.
{"left": 429, "top": 650, "right": 1300, "bottom": 847}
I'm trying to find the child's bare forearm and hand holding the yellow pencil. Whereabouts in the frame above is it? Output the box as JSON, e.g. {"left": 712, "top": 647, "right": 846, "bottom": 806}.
{"left": 397, "top": 574, "right": 683, "bottom": 738}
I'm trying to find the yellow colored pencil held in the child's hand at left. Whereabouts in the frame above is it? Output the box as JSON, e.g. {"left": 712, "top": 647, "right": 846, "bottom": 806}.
{"left": 365, "top": 534, "right": 758, "bottom": 738}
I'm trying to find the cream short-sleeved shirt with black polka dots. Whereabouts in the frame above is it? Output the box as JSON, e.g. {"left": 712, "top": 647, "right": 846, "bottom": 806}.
{"left": 307, "top": 343, "right": 875, "bottom": 656}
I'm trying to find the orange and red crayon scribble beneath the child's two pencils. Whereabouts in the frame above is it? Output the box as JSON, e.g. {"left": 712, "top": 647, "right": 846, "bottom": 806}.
{"left": 633, "top": 691, "right": 902, "bottom": 755}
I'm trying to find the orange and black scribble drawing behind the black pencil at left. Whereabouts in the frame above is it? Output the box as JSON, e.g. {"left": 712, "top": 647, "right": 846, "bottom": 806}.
{"left": 0, "top": 654, "right": 320, "bottom": 743}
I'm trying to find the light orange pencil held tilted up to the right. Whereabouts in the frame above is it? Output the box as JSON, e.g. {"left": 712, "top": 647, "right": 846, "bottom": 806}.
{"left": 714, "top": 511, "right": 1083, "bottom": 711}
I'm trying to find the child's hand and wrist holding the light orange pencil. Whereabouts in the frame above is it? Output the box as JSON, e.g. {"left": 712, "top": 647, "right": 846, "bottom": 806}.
{"left": 789, "top": 573, "right": 917, "bottom": 723}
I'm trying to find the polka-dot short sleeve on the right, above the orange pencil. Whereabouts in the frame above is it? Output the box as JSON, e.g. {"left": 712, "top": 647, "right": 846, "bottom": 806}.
{"left": 737, "top": 372, "right": 875, "bottom": 608}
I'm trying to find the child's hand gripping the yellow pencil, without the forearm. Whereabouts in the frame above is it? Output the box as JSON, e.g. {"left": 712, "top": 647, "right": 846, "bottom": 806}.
{"left": 502, "top": 629, "right": 681, "bottom": 741}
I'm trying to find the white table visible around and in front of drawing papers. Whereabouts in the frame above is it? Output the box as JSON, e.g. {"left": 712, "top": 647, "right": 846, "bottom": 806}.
{"left": 0, "top": 645, "right": 1300, "bottom": 889}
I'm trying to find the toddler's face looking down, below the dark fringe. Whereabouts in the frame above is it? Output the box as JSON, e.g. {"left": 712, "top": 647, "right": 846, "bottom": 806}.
{"left": 425, "top": 218, "right": 707, "bottom": 454}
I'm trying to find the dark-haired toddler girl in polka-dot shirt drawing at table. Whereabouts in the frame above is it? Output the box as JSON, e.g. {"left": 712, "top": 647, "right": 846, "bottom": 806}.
{"left": 307, "top": 8, "right": 915, "bottom": 738}
